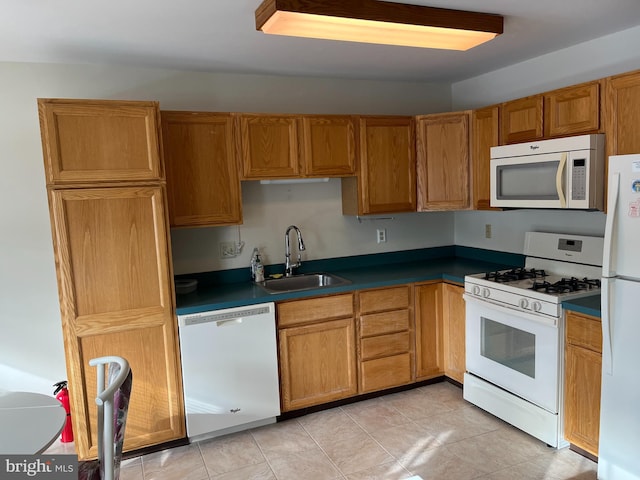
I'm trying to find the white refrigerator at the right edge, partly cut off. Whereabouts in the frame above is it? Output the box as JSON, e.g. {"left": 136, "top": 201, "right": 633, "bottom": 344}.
{"left": 598, "top": 154, "right": 640, "bottom": 480}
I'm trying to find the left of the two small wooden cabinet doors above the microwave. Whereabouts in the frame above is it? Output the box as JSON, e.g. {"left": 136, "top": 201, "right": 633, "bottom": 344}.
{"left": 500, "top": 95, "right": 544, "bottom": 144}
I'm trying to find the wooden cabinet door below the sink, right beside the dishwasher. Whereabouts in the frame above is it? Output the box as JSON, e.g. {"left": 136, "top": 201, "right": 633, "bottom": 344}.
{"left": 279, "top": 318, "right": 358, "bottom": 412}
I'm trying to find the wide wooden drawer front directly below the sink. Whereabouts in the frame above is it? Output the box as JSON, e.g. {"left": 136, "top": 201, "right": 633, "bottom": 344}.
{"left": 276, "top": 293, "right": 353, "bottom": 328}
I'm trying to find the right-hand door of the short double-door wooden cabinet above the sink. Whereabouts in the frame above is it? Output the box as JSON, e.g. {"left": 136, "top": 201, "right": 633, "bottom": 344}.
{"left": 302, "top": 115, "right": 356, "bottom": 177}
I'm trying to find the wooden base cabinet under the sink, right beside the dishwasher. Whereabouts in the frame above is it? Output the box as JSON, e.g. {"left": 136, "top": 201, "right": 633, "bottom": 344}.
{"left": 277, "top": 294, "right": 358, "bottom": 412}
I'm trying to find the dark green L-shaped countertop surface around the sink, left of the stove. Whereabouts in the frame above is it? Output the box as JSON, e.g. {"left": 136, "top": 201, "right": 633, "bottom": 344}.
{"left": 176, "top": 253, "right": 517, "bottom": 315}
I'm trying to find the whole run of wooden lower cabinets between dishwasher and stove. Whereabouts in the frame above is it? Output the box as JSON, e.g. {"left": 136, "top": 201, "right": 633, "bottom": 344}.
{"left": 277, "top": 281, "right": 465, "bottom": 412}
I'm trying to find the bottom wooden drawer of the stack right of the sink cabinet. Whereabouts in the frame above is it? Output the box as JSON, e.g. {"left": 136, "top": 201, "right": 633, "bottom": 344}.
{"left": 360, "top": 353, "right": 413, "bottom": 393}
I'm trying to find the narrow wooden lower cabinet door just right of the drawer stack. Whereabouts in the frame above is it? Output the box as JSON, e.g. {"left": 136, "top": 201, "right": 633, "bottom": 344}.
{"left": 415, "top": 283, "right": 444, "bottom": 380}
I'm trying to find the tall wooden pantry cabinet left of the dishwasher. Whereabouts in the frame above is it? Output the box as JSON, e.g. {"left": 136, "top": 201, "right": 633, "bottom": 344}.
{"left": 38, "top": 99, "right": 185, "bottom": 459}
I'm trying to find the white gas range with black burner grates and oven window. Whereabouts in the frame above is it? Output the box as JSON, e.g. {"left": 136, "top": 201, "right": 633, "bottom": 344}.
{"left": 463, "top": 232, "right": 603, "bottom": 447}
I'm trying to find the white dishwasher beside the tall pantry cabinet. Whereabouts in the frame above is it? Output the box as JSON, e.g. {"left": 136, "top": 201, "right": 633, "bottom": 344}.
{"left": 178, "top": 303, "right": 280, "bottom": 440}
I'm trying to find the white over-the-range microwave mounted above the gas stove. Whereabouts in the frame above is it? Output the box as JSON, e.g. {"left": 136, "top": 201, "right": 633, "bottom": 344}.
{"left": 491, "top": 134, "right": 605, "bottom": 210}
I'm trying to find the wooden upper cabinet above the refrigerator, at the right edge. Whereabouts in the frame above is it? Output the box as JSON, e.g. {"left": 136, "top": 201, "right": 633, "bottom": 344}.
{"left": 604, "top": 70, "right": 640, "bottom": 156}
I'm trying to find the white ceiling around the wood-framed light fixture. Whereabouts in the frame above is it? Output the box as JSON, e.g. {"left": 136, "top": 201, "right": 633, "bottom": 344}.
{"left": 0, "top": 0, "right": 640, "bottom": 81}
